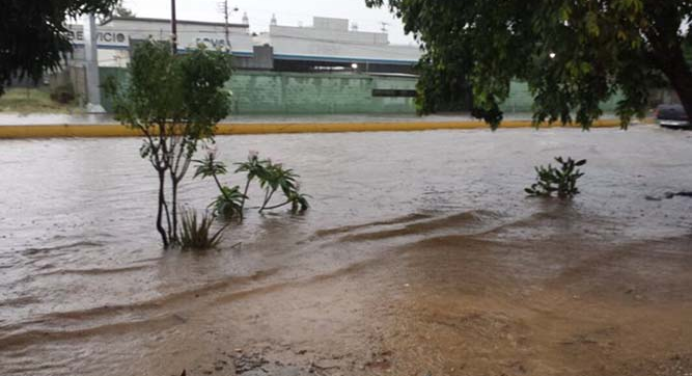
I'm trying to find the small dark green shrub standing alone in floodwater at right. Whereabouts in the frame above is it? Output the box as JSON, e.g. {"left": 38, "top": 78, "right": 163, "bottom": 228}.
{"left": 525, "top": 157, "right": 586, "bottom": 198}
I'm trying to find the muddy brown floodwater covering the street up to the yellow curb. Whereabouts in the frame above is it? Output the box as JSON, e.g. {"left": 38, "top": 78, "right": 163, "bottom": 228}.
{"left": 0, "top": 126, "right": 692, "bottom": 376}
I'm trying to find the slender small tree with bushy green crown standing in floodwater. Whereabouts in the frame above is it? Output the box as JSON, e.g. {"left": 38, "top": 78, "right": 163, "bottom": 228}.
{"left": 104, "top": 41, "right": 231, "bottom": 248}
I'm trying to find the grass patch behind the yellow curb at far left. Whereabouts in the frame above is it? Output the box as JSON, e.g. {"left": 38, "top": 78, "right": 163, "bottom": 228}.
{"left": 0, "top": 88, "right": 82, "bottom": 114}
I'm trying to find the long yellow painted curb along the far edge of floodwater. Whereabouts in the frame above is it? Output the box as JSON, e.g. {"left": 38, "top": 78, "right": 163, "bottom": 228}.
{"left": 0, "top": 119, "right": 636, "bottom": 139}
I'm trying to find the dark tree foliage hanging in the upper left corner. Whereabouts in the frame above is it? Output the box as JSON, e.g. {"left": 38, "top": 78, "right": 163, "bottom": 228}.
{"left": 0, "top": 0, "right": 118, "bottom": 95}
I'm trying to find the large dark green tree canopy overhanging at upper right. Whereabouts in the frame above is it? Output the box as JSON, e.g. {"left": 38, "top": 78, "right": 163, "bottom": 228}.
{"left": 365, "top": 0, "right": 692, "bottom": 128}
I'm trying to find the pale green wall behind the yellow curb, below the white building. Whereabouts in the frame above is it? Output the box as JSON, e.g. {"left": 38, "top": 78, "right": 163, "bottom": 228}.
{"left": 101, "top": 68, "right": 619, "bottom": 115}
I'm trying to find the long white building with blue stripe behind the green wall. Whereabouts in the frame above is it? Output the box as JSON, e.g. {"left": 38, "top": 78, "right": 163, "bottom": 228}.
{"left": 70, "top": 17, "right": 421, "bottom": 73}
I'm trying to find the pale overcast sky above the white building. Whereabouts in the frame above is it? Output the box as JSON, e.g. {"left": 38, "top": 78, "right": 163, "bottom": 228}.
{"left": 125, "top": 0, "right": 413, "bottom": 44}
